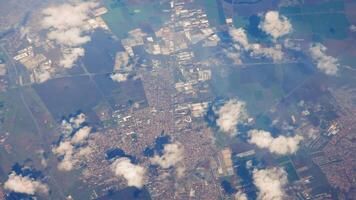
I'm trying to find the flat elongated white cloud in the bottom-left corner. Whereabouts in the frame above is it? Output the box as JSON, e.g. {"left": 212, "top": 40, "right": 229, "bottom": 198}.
{"left": 4, "top": 172, "right": 49, "bottom": 195}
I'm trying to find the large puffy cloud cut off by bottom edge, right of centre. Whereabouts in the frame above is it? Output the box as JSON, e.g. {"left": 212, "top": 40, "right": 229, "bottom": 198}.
{"left": 253, "top": 167, "right": 288, "bottom": 200}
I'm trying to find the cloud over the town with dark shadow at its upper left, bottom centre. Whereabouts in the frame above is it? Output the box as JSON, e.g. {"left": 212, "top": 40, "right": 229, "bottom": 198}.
{"left": 151, "top": 143, "right": 184, "bottom": 169}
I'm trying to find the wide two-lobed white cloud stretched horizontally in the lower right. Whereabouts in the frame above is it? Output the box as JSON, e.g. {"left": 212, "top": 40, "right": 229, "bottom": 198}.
{"left": 248, "top": 130, "right": 303, "bottom": 155}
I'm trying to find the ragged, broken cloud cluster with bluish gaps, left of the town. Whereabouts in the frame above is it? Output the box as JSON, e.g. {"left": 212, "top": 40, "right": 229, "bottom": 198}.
{"left": 52, "top": 113, "right": 92, "bottom": 171}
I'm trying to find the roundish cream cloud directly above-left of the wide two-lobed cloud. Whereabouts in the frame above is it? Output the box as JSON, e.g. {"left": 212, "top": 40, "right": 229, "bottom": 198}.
{"left": 215, "top": 99, "right": 248, "bottom": 135}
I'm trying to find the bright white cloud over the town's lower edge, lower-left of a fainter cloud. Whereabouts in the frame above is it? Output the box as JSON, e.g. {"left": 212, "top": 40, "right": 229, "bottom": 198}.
{"left": 112, "top": 158, "right": 146, "bottom": 188}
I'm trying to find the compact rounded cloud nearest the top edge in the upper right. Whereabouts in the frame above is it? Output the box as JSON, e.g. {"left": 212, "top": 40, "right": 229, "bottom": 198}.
{"left": 259, "top": 11, "right": 293, "bottom": 39}
